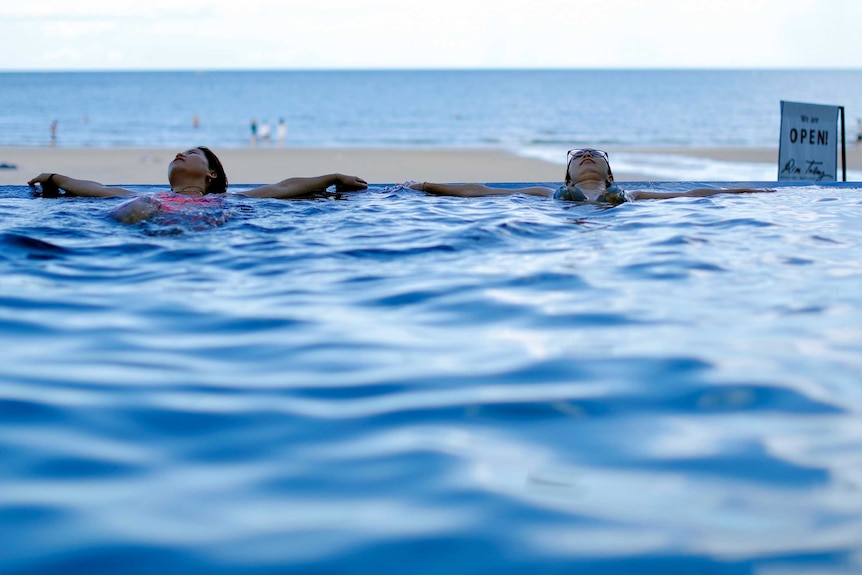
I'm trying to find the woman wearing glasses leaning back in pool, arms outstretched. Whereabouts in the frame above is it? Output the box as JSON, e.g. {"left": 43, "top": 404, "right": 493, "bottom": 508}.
{"left": 410, "top": 148, "right": 773, "bottom": 205}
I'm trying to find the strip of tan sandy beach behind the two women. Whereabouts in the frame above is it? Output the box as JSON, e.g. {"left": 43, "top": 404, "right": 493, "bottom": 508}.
{"left": 0, "top": 147, "right": 862, "bottom": 185}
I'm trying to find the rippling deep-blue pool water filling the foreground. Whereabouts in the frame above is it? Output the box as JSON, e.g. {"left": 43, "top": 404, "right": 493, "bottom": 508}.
{"left": 0, "top": 184, "right": 862, "bottom": 575}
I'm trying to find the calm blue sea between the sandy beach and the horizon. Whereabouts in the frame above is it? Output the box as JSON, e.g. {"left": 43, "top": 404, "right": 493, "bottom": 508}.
{"left": 5, "top": 70, "right": 862, "bottom": 181}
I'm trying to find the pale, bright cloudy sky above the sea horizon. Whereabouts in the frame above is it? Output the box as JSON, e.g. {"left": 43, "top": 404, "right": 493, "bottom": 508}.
{"left": 0, "top": 0, "right": 862, "bottom": 71}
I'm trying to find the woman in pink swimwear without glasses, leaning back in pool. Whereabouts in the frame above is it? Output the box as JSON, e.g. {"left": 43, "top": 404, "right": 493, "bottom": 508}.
{"left": 27, "top": 146, "right": 368, "bottom": 224}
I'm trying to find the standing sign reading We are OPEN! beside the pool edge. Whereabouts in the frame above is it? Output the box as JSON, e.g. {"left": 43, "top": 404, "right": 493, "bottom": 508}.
{"left": 778, "top": 101, "right": 847, "bottom": 182}
